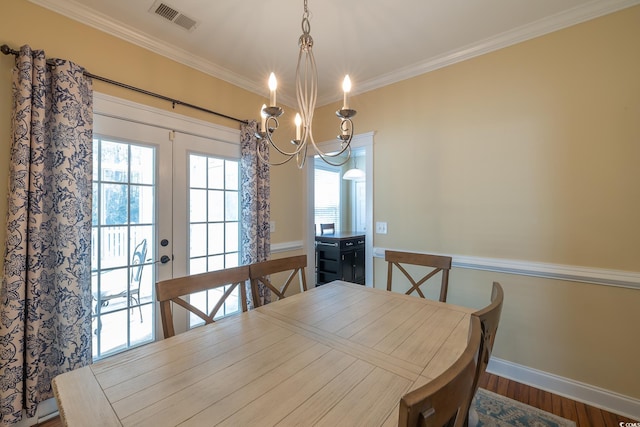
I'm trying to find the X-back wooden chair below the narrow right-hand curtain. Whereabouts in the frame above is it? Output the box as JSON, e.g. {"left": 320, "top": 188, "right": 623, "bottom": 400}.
{"left": 249, "top": 255, "right": 307, "bottom": 307}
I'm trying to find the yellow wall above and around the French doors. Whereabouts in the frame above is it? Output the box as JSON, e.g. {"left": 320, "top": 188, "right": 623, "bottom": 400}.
{"left": 0, "top": 0, "right": 303, "bottom": 266}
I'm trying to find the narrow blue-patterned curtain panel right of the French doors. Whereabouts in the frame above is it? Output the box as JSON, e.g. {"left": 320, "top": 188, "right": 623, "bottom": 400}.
{"left": 240, "top": 120, "right": 271, "bottom": 304}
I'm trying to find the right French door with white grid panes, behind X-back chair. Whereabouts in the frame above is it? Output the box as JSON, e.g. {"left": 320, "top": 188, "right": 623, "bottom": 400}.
{"left": 173, "top": 132, "right": 241, "bottom": 333}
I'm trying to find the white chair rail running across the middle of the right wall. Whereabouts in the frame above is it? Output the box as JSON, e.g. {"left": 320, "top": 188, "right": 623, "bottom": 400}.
{"left": 373, "top": 247, "right": 640, "bottom": 289}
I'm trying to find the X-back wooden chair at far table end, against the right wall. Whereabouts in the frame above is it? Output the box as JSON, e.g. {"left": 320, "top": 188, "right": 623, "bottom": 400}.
{"left": 384, "top": 251, "right": 451, "bottom": 302}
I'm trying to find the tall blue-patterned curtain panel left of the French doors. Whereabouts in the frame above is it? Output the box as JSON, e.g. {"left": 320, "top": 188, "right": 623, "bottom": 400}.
{"left": 0, "top": 46, "right": 93, "bottom": 425}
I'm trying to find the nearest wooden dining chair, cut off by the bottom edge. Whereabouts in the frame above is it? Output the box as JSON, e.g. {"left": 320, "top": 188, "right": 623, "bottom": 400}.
{"left": 398, "top": 316, "right": 481, "bottom": 427}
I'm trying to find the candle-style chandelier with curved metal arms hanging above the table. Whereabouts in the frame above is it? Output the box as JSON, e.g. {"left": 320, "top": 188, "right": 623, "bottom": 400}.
{"left": 256, "top": 0, "right": 356, "bottom": 168}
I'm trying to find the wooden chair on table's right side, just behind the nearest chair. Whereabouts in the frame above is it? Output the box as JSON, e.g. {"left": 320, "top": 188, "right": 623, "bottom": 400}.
{"left": 467, "top": 282, "right": 504, "bottom": 426}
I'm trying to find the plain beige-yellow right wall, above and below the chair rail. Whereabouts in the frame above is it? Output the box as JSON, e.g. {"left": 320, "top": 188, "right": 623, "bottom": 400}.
{"left": 315, "top": 6, "right": 640, "bottom": 398}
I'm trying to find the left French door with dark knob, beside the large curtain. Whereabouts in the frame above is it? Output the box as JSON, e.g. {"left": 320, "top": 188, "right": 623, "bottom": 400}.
{"left": 91, "top": 115, "right": 172, "bottom": 359}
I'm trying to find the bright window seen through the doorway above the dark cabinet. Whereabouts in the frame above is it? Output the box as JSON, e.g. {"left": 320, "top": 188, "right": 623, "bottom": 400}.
{"left": 314, "top": 166, "right": 341, "bottom": 233}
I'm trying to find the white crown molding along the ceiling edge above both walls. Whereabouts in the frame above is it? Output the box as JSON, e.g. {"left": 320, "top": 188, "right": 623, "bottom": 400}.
{"left": 29, "top": 0, "right": 640, "bottom": 106}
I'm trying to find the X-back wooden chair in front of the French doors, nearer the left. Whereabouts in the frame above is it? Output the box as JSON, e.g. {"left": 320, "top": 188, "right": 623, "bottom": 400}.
{"left": 156, "top": 265, "right": 249, "bottom": 338}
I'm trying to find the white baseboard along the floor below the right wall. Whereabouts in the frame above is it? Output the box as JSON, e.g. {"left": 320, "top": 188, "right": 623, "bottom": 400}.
{"left": 487, "top": 357, "right": 640, "bottom": 420}
